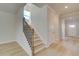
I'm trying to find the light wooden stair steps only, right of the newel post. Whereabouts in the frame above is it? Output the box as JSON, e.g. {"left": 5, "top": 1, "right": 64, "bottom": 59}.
{"left": 34, "top": 32, "right": 45, "bottom": 55}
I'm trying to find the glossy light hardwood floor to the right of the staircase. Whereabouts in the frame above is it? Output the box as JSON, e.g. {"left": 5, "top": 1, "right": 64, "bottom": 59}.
{"left": 36, "top": 38, "right": 79, "bottom": 56}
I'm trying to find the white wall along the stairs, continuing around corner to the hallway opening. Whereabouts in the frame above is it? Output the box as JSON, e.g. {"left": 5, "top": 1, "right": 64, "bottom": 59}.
{"left": 32, "top": 5, "right": 59, "bottom": 47}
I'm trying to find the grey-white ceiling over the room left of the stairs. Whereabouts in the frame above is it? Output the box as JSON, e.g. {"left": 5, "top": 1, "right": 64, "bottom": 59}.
{"left": 0, "top": 3, "right": 25, "bottom": 14}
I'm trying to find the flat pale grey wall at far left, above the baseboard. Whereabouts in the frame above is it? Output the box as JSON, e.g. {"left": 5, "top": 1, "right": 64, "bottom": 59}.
{"left": 0, "top": 11, "right": 16, "bottom": 44}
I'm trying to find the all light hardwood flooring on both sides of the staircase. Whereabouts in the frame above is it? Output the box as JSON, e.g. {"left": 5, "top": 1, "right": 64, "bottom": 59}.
{"left": 0, "top": 39, "right": 79, "bottom": 56}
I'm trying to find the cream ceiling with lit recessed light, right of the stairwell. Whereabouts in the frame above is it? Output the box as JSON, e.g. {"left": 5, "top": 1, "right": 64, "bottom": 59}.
{"left": 36, "top": 3, "right": 79, "bottom": 15}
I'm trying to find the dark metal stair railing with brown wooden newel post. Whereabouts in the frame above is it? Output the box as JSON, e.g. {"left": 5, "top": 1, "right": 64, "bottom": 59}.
{"left": 23, "top": 18, "right": 34, "bottom": 54}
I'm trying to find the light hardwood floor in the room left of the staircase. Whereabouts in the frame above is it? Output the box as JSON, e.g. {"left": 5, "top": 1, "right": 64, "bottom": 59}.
{"left": 0, "top": 42, "right": 28, "bottom": 56}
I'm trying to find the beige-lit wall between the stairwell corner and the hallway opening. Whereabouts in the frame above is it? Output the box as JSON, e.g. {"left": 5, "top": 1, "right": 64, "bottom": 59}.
{"left": 47, "top": 6, "right": 59, "bottom": 45}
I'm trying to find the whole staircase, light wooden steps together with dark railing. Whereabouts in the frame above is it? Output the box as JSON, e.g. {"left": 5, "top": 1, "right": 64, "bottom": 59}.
{"left": 23, "top": 18, "right": 45, "bottom": 55}
